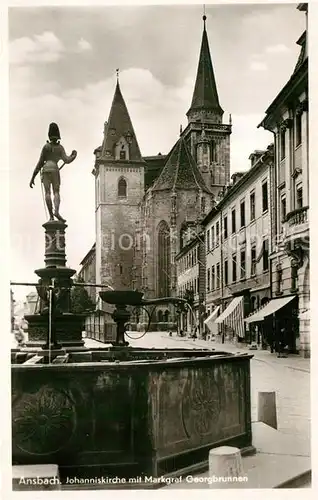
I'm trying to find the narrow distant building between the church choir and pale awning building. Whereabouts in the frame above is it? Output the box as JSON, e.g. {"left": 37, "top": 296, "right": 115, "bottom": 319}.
{"left": 176, "top": 227, "right": 205, "bottom": 335}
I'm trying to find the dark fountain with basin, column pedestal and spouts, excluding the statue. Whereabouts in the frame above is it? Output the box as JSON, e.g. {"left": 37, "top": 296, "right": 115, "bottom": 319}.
{"left": 11, "top": 135, "right": 254, "bottom": 487}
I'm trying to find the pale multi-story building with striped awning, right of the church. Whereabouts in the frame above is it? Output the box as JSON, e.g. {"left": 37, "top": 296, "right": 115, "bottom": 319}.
{"left": 202, "top": 145, "right": 274, "bottom": 340}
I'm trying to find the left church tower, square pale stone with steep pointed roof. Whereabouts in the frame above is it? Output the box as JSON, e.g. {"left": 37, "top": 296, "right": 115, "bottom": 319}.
{"left": 93, "top": 77, "right": 145, "bottom": 290}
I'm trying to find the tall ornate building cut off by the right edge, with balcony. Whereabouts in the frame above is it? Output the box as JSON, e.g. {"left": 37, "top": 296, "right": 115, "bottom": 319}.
{"left": 259, "top": 3, "right": 310, "bottom": 357}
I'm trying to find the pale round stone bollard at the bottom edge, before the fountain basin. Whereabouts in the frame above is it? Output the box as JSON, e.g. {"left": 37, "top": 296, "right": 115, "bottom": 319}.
{"left": 209, "top": 446, "right": 244, "bottom": 489}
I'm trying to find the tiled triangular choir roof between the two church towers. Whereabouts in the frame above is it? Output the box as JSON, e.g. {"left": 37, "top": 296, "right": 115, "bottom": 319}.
{"left": 152, "top": 137, "right": 211, "bottom": 194}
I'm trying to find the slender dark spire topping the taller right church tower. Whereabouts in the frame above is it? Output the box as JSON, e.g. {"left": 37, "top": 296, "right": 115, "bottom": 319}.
{"left": 187, "top": 15, "right": 223, "bottom": 115}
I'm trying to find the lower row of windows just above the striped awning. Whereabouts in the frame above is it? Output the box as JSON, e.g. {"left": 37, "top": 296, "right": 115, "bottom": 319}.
{"left": 206, "top": 240, "right": 269, "bottom": 292}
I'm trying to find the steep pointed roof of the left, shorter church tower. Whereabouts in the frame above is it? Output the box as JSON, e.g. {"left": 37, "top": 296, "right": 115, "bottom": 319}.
{"left": 102, "top": 79, "right": 143, "bottom": 162}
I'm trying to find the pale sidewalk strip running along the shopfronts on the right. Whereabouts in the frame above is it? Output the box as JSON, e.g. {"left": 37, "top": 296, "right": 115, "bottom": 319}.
{"left": 162, "top": 334, "right": 310, "bottom": 373}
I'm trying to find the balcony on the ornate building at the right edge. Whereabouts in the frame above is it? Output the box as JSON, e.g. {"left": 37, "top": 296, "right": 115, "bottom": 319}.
{"left": 284, "top": 207, "right": 309, "bottom": 248}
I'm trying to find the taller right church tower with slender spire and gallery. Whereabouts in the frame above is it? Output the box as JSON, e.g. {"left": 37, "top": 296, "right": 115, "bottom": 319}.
{"left": 183, "top": 15, "right": 232, "bottom": 198}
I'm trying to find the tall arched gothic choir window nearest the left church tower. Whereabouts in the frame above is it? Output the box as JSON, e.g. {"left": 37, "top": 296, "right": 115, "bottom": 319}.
{"left": 157, "top": 221, "right": 171, "bottom": 297}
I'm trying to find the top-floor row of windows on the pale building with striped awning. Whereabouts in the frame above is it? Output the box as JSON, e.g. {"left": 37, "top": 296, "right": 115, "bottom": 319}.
{"left": 206, "top": 181, "right": 268, "bottom": 252}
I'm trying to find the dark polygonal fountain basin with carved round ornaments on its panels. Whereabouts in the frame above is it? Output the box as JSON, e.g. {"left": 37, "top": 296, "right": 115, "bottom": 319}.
{"left": 12, "top": 349, "right": 252, "bottom": 480}
